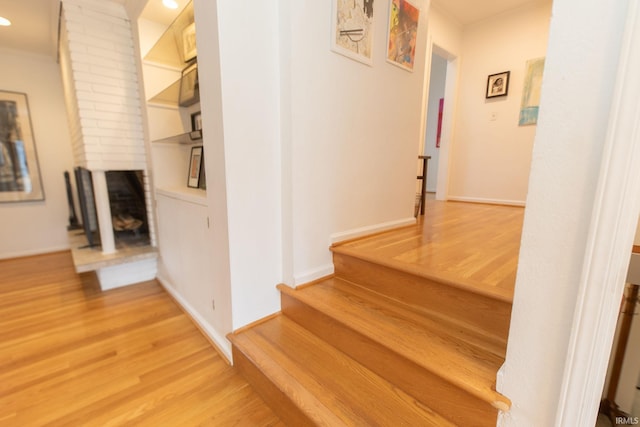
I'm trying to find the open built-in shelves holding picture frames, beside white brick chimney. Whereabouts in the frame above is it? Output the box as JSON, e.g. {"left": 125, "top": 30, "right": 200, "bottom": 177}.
{"left": 141, "top": 2, "right": 206, "bottom": 198}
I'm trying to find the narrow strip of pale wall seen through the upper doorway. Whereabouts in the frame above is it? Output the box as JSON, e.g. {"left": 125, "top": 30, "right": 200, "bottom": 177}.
{"left": 423, "top": 53, "right": 444, "bottom": 192}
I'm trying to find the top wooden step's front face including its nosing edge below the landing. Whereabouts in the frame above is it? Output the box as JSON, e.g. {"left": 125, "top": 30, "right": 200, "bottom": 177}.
{"left": 331, "top": 246, "right": 512, "bottom": 347}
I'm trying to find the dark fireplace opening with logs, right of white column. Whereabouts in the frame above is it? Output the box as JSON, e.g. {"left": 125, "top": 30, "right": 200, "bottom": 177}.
{"left": 105, "top": 170, "right": 150, "bottom": 247}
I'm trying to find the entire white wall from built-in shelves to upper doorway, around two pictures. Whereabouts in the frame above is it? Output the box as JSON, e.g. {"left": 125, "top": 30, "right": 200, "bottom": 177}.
{"left": 196, "top": 1, "right": 427, "bottom": 328}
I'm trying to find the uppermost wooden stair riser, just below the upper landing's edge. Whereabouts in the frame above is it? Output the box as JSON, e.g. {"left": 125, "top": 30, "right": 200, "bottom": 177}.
{"left": 333, "top": 252, "right": 511, "bottom": 341}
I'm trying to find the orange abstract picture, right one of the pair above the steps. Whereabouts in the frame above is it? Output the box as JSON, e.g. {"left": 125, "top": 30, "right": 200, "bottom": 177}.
{"left": 387, "top": 0, "right": 420, "bottom": 71}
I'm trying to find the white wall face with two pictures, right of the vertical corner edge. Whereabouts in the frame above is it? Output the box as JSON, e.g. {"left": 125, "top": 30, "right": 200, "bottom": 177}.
{"left": 283, "top": 1, "right": 428, "bottom": 283}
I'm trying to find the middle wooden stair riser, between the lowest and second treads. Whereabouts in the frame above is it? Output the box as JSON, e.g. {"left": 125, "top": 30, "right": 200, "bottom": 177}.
{"left": 281, "top": 294, "right": 497, "bottom": 426}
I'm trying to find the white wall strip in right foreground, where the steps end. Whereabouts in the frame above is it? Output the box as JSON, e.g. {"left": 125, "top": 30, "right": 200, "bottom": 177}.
{"left": 498, "top": 0, "right": 629, "bottom": 427}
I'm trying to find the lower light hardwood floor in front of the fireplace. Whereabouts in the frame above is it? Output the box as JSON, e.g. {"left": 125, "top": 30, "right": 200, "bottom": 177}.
{"left": 0, "top": 252, "right": 284, "bottom": 427}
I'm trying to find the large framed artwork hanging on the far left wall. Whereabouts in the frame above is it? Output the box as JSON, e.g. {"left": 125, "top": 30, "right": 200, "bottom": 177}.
{"left": 0, "top": 91, "right": 44, "bottom": 202}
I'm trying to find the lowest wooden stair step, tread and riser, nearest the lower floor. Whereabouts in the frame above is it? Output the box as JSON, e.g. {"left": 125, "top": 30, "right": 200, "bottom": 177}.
{"left": 229, "top": 315, "right": 454, "bottom": 426}
